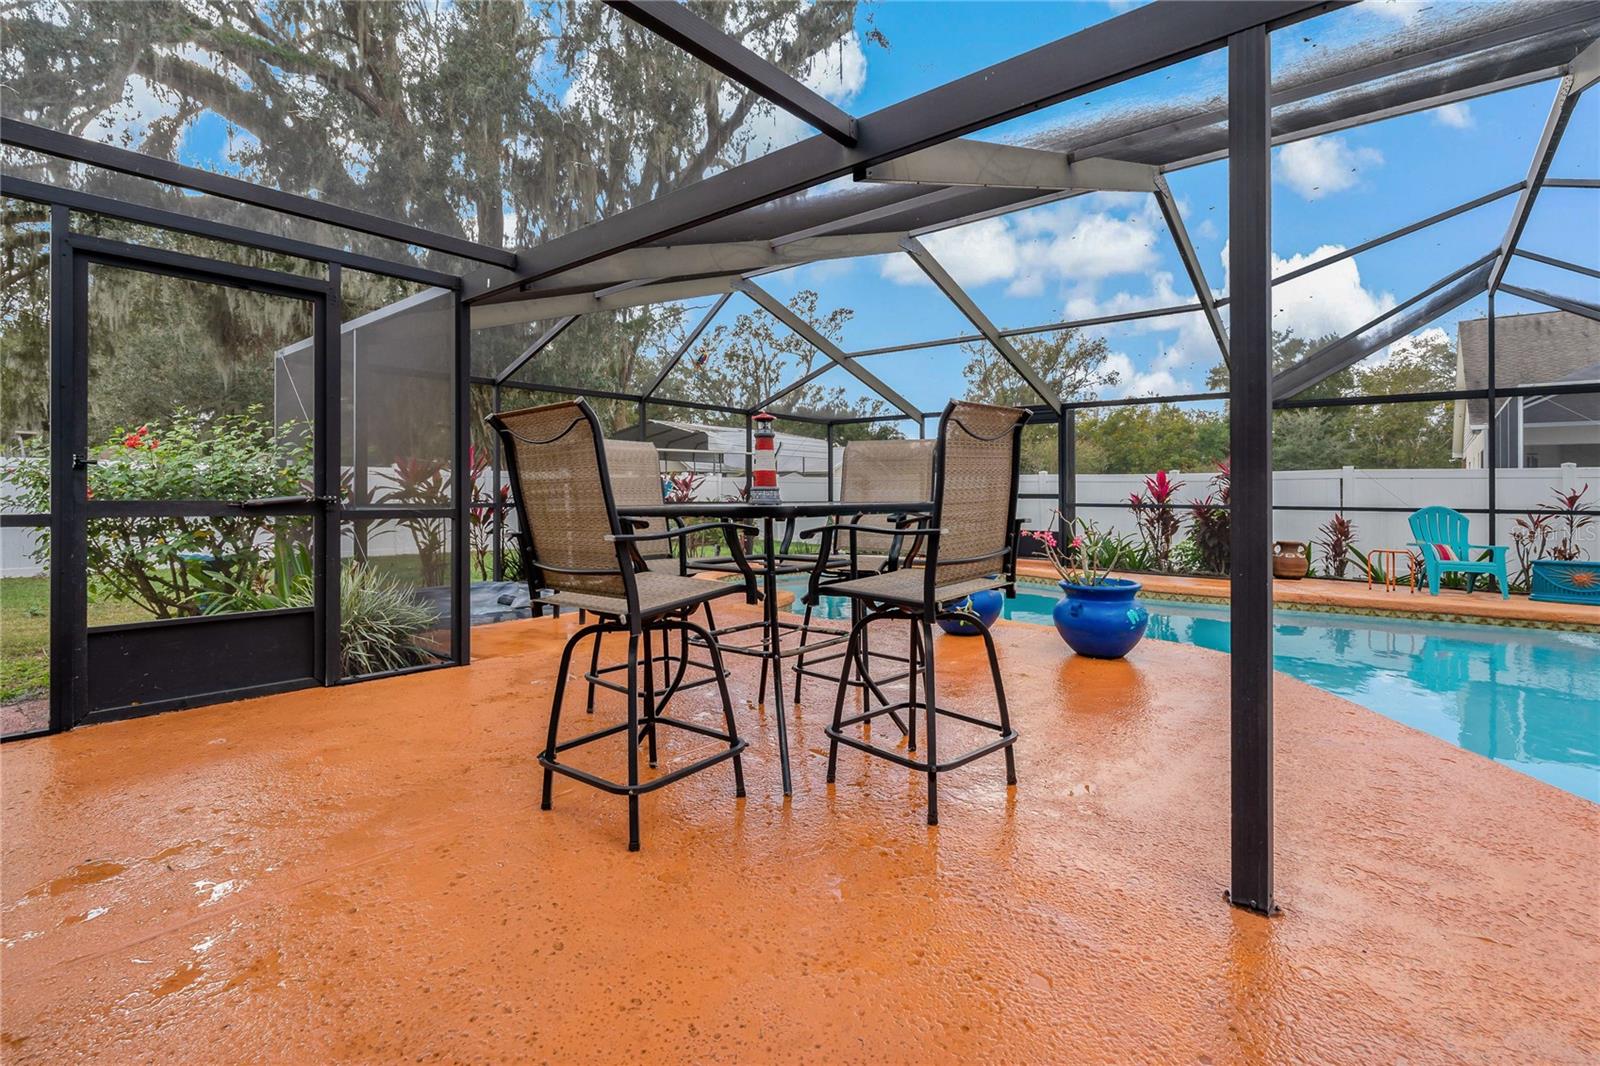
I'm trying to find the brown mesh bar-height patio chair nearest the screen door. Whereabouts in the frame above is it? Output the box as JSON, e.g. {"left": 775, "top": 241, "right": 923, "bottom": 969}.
{"left": 488, "top": 400, "right": 747, "bottom": 852}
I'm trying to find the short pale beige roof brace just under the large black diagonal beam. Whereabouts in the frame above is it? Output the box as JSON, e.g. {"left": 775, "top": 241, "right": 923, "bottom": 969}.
{"left": 856, "top": 138, "right": 1160, "bottom": 192}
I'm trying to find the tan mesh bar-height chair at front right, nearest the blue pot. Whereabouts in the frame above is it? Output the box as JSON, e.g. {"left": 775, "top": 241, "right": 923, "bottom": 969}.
{"left": 822, "top": 400, "right": 1027, "bottom": 826}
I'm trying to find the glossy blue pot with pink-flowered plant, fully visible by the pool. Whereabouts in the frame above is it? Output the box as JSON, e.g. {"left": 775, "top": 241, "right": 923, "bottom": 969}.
{"left": 1027, "top": 514, "right": 1150, "bottom": 659}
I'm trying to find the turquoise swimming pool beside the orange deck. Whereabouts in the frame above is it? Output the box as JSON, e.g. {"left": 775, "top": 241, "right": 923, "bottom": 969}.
{"left": 782, "top": 578, "right": 1600, "bottom": 804}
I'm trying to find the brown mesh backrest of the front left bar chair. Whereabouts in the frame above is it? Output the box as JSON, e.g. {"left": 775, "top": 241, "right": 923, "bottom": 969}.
{"left": 488, "top": 400, "right": 627, "bottom": 595}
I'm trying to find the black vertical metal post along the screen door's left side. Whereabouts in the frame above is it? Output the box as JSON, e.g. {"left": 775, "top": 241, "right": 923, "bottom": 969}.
{"left": 50, "top": 206, "right": 88, "bottom": 733}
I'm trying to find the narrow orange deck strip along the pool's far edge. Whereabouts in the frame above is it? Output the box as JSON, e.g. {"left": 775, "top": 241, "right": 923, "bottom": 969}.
{"left": 1018, "top": 559, "right": 1600, "bottom": 632}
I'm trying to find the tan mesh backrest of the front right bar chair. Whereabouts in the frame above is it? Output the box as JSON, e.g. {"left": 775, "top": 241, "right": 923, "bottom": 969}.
{"left": 928, "top": 400, "right": 1027, "bottom": 595}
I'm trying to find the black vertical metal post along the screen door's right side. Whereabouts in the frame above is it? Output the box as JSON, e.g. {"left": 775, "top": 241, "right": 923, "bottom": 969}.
{"left": 312, "top": 262, "right": 344, "bottom": 685}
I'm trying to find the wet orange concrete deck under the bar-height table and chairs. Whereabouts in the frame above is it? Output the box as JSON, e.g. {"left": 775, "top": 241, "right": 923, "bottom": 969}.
{"left": 0, "top": 610, "right": 1600, "bottom": 1063}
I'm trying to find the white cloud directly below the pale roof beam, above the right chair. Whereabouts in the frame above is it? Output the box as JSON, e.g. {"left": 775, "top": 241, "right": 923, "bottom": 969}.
{"left": 883, "top": 194, "right": 1160, "bottom": 296}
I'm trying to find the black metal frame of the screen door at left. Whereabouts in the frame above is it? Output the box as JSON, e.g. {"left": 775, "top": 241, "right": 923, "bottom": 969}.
{"left": 50, "top": 228, "right": 341, "bottom": 731}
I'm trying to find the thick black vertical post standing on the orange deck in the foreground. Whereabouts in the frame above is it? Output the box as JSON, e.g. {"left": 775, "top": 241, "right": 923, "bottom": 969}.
{"left": 1227, "top": 26, "right": 1274, "bottom": 914}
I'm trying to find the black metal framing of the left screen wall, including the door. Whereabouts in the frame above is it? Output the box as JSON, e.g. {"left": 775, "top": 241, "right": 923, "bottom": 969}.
{"left": 3, "top": 188, "right": 470, "bottom": 741}
